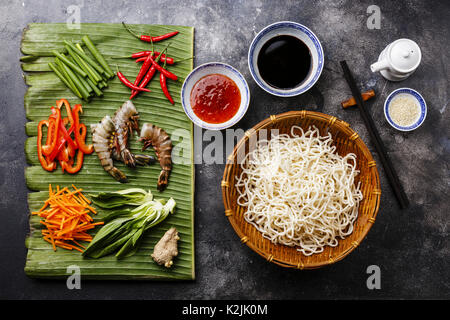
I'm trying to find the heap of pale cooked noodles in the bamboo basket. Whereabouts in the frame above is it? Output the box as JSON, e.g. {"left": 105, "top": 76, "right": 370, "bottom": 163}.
{"left": 236, "top": 126, "right": 363, "bottom": 256}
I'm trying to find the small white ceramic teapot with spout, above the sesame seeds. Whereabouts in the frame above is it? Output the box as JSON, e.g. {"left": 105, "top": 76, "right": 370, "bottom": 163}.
{"left": 370, "top": 39, "right": 422, "bottom": 81}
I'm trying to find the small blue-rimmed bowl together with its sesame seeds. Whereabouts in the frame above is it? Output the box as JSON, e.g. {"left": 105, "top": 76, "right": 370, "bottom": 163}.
{"left": 384, "top": 88, "right": 427, "bottom": 131}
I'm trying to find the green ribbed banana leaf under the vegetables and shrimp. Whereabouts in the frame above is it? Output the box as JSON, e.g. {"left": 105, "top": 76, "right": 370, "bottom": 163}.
{"left": 21, "top": 23, "right": 195, "bottom": 280}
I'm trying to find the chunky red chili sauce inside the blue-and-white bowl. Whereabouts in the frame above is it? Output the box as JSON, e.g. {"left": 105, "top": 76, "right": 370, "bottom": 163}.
{"left": 191, "top": 74, "right": 241, "bottom": 123}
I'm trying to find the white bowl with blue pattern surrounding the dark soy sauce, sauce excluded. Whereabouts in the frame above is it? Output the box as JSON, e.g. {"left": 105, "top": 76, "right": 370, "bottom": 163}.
{"left": 248, "top": 21, "right": 324, "bottom": 97}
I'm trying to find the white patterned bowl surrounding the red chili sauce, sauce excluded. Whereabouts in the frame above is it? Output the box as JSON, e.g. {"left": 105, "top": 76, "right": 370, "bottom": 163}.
{"left": 181, "top": 62, "right": 250, "bottom": 130}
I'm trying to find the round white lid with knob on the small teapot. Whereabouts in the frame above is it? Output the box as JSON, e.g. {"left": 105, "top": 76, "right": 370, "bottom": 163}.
{"left": 389, "top": 39, "right": 422, "bottom": 73}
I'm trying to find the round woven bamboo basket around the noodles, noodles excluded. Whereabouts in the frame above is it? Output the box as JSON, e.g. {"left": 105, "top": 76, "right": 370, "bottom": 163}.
{"left": 221, "top": 110, "right": 381, "bottom": 269}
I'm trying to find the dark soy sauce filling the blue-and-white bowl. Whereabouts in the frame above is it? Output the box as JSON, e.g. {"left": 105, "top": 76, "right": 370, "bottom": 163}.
{"left": 257, "top": 35, "right": 311, "bottom": 89}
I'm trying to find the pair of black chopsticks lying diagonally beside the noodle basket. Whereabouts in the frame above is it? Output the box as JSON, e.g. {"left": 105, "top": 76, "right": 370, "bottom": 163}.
{"left": 341, "top": 60, "right": 409, "bottom": 209}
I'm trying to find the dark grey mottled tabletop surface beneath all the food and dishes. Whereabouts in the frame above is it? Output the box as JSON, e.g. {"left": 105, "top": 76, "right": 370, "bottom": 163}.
{"left": 0, "top": 0, "right": 450, "bottom": 299}
